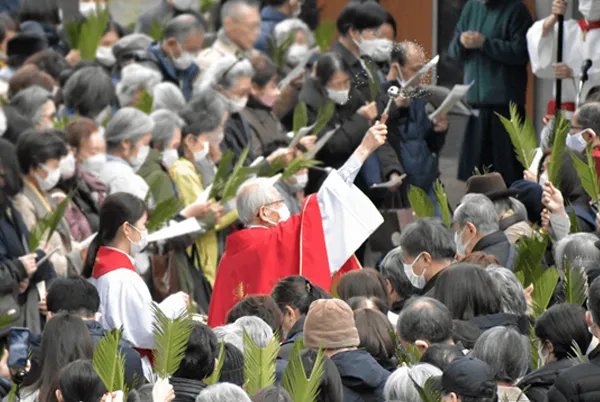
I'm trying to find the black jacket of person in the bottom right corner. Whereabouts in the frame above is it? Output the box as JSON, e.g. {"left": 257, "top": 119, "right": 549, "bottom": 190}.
{"left": 548, "top": 346, "right": 600, "bottom": 402}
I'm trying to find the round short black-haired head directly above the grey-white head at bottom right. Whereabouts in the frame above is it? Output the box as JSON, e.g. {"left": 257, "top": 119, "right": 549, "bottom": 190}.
{"left": 396, "top": 297, "right": 452, "bottom": 343}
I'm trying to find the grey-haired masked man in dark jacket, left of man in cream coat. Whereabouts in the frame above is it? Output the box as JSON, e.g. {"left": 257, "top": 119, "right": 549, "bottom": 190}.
{"left": 138, "top": 14, "right": 204, "bottom": 100}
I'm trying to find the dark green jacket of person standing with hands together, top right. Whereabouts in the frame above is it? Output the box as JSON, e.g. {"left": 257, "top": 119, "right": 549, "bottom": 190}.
{"left": 448, "top": 0, "right": 533, "bottom": 106}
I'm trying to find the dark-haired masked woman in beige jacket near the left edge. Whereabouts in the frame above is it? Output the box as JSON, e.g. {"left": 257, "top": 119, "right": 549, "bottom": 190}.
{"left": 14, "top": 130, "right": 83, "bottom": 276}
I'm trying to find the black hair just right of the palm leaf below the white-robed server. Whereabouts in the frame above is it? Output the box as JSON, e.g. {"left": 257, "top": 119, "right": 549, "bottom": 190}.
{"left": 174, "top": 322, "right": 219, "bottom": 381}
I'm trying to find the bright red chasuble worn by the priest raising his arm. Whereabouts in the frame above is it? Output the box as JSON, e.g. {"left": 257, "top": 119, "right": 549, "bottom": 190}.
{"left": 208, "top": 194, "right": 360, "bottom": 328}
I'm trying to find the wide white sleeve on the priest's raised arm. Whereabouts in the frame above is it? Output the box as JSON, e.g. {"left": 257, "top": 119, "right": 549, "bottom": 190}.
{"left": 317, "top": 163, "right": 383, "bottom": 273}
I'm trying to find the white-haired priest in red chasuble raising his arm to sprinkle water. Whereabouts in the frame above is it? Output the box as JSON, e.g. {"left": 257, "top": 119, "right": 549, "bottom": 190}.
{"left": 208, "top": 124, "right": 387, "bottom": 327}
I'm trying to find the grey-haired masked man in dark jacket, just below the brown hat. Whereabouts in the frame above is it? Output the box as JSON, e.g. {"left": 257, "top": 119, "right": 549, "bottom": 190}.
{"left": 454, "top": 194, "right": 517, "bottom": 269}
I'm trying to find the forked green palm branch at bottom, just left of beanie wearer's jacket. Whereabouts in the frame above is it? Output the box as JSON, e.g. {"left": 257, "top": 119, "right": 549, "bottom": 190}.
{"left": 283, "top": 337, "right": 325, "bottom": 402}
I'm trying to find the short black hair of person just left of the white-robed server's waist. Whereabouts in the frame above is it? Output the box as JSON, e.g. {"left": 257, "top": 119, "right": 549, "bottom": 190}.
{"left": 46, "top": 276, "right": 100, "bottom": 318}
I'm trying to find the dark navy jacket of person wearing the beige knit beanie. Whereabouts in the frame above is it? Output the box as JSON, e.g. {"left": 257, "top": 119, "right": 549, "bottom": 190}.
{"left": 331, "top": 350, "right": 390, "bottom": 402}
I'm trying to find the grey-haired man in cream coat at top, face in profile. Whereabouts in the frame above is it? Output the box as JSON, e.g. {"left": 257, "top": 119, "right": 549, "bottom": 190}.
{"left": 198, "top": 0, "right": 260, "bottom": 71}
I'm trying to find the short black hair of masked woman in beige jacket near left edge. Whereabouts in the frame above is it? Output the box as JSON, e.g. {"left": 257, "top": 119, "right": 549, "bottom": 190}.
{"left": 17, "top": 129, "right": 68, "bottom": 174}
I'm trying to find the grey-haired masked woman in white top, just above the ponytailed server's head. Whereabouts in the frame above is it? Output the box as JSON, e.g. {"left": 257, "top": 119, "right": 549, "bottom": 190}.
{"left": 99, "top": 107, "right": 154, "bottom": 200}
